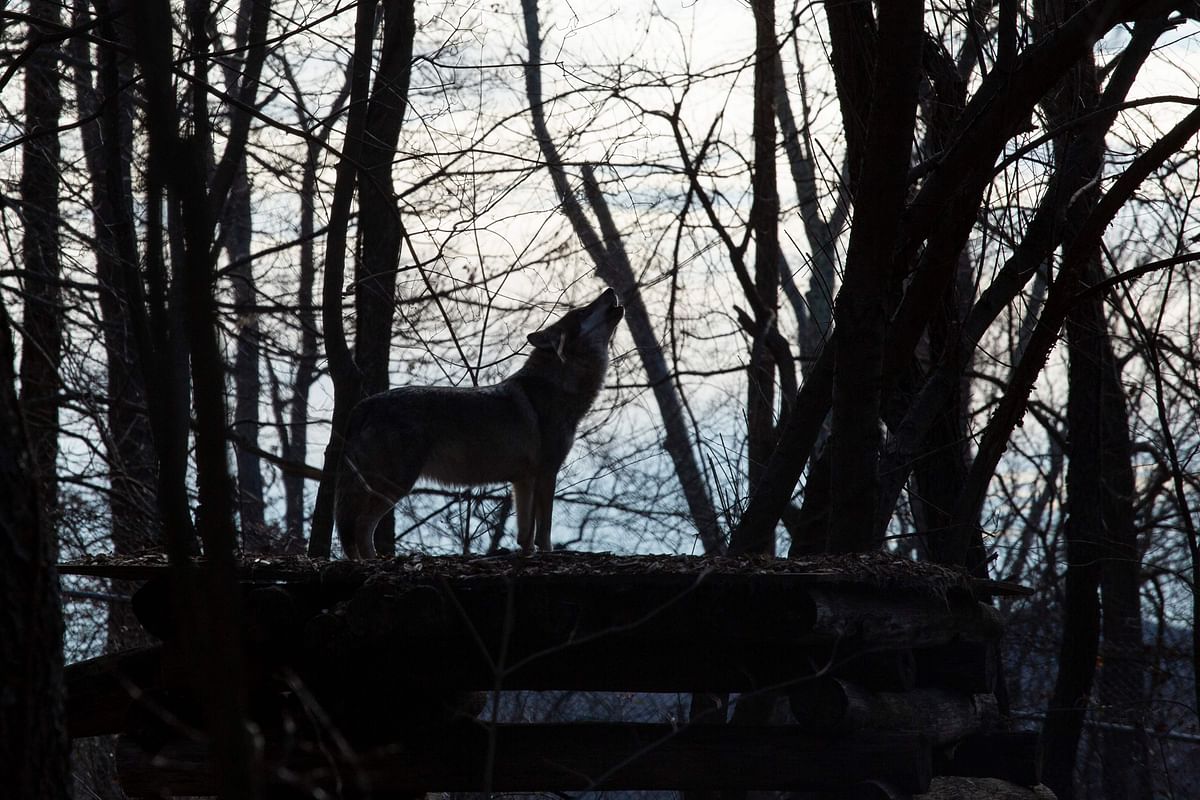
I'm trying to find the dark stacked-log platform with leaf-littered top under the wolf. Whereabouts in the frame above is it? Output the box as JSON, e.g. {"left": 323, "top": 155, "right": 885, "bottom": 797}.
{"left": 61, "top": 554, "right": 1037, "bottom": 796}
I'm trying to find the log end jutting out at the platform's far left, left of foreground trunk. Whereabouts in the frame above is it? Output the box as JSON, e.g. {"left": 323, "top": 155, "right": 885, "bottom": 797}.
{"left": 64, "top": 645, "right": 162, "bottom": 739}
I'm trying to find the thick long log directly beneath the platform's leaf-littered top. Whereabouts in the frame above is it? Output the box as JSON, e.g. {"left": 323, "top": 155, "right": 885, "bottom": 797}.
{"left": 298, "top": 575, "right": 998, "bottom": 692}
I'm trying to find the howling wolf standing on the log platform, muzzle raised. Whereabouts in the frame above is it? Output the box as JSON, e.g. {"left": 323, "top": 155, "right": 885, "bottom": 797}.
{"left": 336, "top": 289, "right": 625, "bottom": 559}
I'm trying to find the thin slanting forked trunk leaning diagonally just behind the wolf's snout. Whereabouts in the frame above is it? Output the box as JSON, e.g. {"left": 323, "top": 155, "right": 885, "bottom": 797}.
{"left": 521, "top": 0, "right": 725, "bottom": 554}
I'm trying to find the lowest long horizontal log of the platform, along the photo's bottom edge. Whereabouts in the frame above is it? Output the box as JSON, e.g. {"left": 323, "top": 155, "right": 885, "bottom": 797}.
{"left": 116, "top": 723, "right": 931, "bottom": 796}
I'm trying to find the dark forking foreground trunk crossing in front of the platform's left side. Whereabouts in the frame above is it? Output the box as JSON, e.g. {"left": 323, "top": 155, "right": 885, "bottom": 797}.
{"left": 133, "top": 0, "right": 270, "bottom": 798}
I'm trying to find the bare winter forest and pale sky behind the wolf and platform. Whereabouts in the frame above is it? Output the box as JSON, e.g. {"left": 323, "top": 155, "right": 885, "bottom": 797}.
{"left": 0, "top": 0, "right": 1200, "bottom": 798}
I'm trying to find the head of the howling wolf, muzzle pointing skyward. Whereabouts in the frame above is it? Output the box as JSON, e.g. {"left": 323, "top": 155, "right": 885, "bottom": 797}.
{"left": 527, "top": 289, "right": 625, "bottom": 391}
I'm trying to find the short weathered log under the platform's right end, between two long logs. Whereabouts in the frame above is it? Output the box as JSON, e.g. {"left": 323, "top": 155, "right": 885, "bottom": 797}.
{"left": 790, "top": 678, "right": 998, "bottom": 745}
